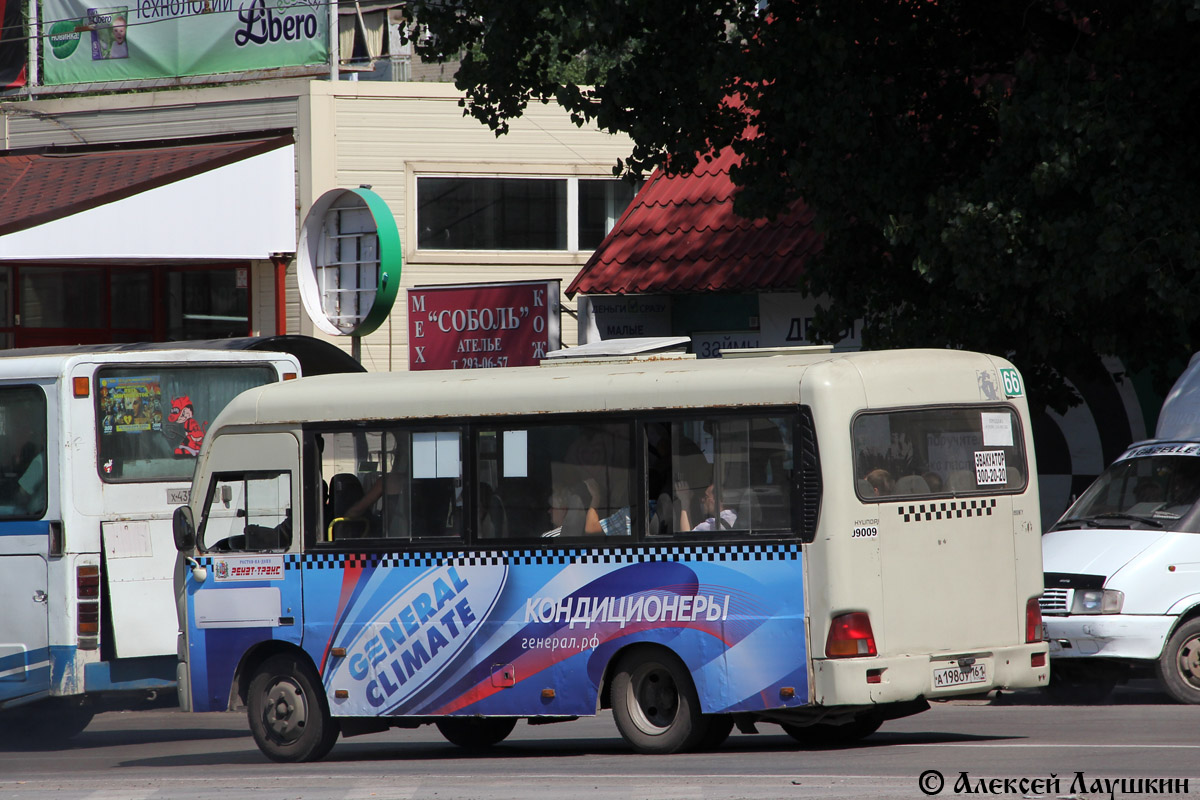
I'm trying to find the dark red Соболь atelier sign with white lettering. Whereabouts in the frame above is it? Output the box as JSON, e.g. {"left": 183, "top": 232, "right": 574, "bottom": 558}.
{"left": 408, "top": 281, "right": 559, "bottom": 369}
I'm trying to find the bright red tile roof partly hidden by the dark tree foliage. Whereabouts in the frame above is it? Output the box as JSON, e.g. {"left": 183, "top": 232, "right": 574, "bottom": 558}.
{"left": 566, "top": 144, "right": 822, "bottom": 297}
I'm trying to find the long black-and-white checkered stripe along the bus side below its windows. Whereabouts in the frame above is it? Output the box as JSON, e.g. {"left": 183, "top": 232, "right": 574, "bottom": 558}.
{"left": 197, "top": 545, "right": 802, "bottom": 570}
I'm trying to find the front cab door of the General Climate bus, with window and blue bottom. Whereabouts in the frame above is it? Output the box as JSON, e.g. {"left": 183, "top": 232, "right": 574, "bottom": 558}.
{"left": 185, "top": 433, "right": 304, "bottom": 711}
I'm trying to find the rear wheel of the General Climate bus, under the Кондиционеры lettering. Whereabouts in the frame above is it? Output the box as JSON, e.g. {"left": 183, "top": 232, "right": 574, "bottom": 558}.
{"left": 612, "top": 648, "right": 709, "bottom": 754}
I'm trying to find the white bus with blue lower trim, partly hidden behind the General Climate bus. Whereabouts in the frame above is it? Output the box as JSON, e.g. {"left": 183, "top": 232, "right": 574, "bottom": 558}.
{"left": 0, "top": 343, "right": 309, "bottom": 741}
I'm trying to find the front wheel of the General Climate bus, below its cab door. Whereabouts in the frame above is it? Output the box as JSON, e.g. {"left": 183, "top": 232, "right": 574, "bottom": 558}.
{"left": 246, "top": 654, "right": 340, "bottom": 763}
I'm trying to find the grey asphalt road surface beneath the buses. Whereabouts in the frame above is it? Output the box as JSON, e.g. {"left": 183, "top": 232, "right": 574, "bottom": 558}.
{"left": 0, "top": 686, "right": 1200, "bottom": 800}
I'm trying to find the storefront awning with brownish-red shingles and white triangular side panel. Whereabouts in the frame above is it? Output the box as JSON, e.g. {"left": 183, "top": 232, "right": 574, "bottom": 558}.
{"left": 0, "top": 134, "right": 296, "bottom": 261}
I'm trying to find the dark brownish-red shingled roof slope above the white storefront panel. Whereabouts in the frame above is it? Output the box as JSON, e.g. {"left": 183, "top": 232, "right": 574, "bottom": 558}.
{"left": 0, "top": 136, "right": 292, "bottom": 237}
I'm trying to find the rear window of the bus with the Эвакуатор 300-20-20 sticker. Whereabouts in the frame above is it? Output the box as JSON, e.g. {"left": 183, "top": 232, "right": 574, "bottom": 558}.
{"left": 853, "top": 407, "right": 1028, "bottom": 501}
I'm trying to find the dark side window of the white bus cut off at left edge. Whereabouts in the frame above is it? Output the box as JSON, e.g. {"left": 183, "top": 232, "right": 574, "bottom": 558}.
{"left": 0, "top": 386, "right": 47, "bottom": 519}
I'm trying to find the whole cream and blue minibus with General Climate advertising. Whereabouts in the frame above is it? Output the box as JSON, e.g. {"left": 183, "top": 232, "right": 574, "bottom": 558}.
{"left": 175, "top": 350, "right": 1049, "bottom": 762}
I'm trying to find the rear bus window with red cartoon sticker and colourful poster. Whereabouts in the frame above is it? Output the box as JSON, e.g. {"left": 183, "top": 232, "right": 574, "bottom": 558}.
{"left": 95, "top": 365, "right": 276, "bottom": 483}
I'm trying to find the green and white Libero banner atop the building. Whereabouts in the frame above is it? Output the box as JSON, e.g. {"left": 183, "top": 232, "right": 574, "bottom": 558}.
{"left": 42, "top": 0, "right": 329, "bottom": 85}
